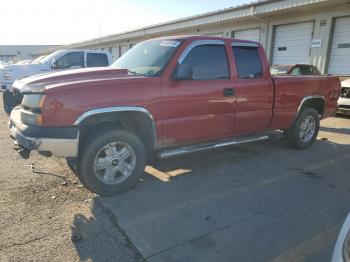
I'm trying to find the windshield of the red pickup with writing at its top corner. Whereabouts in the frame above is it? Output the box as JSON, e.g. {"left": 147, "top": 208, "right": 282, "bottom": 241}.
{"left": 111, "top": 40, "right": 181, "bottom": 76}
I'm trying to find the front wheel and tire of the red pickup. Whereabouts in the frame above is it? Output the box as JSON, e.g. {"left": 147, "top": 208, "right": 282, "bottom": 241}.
{"left": 77, "top": 129, "right": 146, "bottom": 196}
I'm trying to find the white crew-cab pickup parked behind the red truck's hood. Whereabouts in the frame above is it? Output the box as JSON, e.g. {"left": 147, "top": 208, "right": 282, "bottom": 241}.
{"left": 0, "top": 50, "right": 113, "bottom": 91}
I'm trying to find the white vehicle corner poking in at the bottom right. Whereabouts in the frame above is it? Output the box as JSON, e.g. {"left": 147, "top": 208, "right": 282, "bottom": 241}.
{"left": 331, "top": 214, "right": 350, "bottom": 262}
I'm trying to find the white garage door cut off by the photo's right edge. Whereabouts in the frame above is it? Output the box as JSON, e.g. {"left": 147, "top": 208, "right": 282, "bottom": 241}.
{"left": 328, "top": 17, "right": 350, "bottom": 74}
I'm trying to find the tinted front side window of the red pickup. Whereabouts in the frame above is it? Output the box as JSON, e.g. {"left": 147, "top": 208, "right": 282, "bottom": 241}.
{"left": 177, "top": 45, "right": 230, "bottom": 80}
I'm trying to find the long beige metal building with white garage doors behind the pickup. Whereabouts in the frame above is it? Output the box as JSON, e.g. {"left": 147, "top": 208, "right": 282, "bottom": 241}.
{"left": 33, "top": 0, "right": 350, "bottom": 75}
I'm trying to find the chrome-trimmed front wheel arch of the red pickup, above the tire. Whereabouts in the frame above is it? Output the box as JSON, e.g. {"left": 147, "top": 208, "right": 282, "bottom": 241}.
{"left": 73, "top": 106, "right": 158, "bottom": 149}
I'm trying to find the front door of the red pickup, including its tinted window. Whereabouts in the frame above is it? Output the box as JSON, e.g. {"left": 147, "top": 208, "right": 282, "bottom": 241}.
{"left": 161, "top": 40, "right": 235, "bottom": 145}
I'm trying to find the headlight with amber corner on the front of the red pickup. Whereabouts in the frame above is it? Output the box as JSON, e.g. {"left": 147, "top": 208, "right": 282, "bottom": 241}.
{"left": 21, "top": 94, "right": 46, "bottom": 125}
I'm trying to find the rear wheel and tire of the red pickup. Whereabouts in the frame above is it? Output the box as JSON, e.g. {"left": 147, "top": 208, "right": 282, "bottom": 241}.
{"left": 287, "top": 107, "right": 320, "bottom": 149}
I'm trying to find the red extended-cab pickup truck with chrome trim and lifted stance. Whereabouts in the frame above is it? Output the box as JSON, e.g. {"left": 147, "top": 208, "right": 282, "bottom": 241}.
{"left": 9, "top": 36, "right": 340, "bottom": 195}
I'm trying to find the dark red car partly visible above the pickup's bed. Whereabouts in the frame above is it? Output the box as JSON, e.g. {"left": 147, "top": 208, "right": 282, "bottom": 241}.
{"left": 271, "top": 64, "right": 321, "bottom": 76}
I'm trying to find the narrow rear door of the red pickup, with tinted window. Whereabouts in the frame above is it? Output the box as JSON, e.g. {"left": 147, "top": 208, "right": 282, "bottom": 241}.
{"left": 232, "top": 42, "right": 274, "bottom": 134}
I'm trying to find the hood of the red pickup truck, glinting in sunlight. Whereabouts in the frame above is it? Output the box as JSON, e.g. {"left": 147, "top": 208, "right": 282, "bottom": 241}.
{"left": 13, "top": 67, "right": 141, "bottom": 92}
